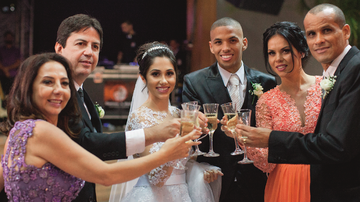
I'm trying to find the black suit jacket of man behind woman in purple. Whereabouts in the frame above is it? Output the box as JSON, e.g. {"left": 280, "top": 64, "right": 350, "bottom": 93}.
{"left": 73, "top": 89, "right": 126, "bottom": 202}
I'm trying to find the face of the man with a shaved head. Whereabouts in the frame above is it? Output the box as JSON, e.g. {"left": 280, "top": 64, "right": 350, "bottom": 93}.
{"left": 304, "top": 9, "right": 350, "bottom": 70}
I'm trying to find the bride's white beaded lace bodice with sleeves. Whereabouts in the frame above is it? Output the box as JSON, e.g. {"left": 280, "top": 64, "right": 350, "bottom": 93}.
{"left": 125, "top": 106, "right": 183, "bottom": 185}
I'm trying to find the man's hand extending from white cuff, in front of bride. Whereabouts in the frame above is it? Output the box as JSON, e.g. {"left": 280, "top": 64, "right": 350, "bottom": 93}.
{"left": 144, "top": 118, "right": 180, "bottom": 146}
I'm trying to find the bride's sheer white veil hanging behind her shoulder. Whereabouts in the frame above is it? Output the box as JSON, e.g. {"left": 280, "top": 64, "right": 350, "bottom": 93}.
{"left": 109, "top": 76, "right": 149, "bottom": 202}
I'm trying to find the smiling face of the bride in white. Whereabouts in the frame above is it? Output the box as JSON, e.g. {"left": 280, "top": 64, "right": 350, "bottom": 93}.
{"left": 141, "top": 57, "right": 176, "bottom": 100}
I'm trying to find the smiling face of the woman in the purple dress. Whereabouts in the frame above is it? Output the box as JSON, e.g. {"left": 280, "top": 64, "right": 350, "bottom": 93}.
{"left": 32, "top": 61, "right": 71, "bottom": 124}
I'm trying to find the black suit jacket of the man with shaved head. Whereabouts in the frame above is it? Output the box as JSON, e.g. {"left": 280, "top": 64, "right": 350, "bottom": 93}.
{"left": 269, "top": 47, "right": 360, "bottom": 202}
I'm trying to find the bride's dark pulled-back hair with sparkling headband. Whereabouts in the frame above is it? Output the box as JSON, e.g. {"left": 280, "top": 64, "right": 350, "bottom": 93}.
{"left": 136, "top": 41, "right": 177, "bottom": 80}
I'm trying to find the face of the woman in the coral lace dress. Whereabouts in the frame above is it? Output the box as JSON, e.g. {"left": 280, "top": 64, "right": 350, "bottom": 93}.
{"left": 268, "top": 34, "right": 302, "bottom": 78}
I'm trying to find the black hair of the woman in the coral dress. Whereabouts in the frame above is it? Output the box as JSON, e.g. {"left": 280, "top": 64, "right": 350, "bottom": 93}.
{"left": 263, "top": 21, "right": 309, "bottom": 76}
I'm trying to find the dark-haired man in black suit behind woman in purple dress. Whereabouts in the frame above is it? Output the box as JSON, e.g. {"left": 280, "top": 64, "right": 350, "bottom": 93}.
{"left": 55, "top": 14, "right": 186, "bottom": 202}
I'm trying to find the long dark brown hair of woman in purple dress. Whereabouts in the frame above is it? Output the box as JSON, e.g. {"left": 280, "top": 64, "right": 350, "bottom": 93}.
{"left": 0, "top": 53, "right": 81, "bottom": 137}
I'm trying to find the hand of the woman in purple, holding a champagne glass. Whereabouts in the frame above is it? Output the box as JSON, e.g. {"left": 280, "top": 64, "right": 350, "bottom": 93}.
{"left": 159, "top": 129, "right": 201, "bottom": 161}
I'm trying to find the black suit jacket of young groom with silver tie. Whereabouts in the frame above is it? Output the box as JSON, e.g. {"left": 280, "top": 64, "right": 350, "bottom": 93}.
{"left": 182, "top": 63, "right": 276, "bottom": 202}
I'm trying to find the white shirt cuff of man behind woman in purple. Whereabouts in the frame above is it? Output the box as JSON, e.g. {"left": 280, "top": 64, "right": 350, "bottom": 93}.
{"left": 125, "top": 129, "right": 145, "bottom": 156}
